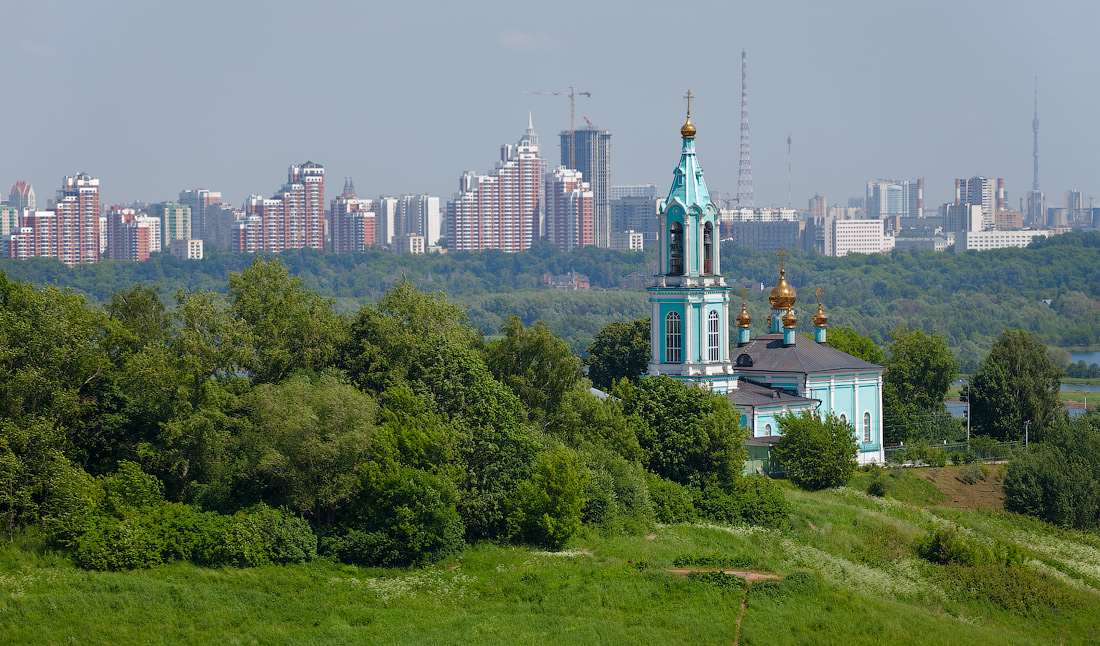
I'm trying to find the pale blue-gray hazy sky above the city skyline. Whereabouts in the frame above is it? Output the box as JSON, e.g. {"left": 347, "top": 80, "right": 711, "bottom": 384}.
{"left": 0, "top": 0, "right": 1100, "bottom": 208}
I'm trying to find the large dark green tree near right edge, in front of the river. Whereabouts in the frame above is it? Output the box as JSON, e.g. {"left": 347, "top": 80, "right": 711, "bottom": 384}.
{"left": 966, "top": 330, "right": 1064, "bottom": 440}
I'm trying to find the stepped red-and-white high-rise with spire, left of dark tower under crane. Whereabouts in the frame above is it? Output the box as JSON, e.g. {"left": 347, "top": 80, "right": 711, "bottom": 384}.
{"left": 446, "top": 120, "right": 542, "bottom": 252}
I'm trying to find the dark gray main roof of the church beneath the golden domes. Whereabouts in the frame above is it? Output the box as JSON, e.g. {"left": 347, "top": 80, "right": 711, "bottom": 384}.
{"left": 732, "top": 335, "right": 882, "bottom": 374}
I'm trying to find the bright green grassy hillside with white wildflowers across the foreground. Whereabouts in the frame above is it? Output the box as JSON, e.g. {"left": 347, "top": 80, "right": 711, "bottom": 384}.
{"left": 0, "top": 470, "right": 1100, "bottom": 644}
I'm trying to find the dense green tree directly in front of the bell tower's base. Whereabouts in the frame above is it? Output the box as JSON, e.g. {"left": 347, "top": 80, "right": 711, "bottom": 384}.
{"left": 614, "top": 375, "right": 746, "bottom": 488}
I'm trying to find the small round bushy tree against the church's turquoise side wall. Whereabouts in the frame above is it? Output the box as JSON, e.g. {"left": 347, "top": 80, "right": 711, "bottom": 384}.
{"left": 773, "top": 410, "right": 859, "bottom": 491}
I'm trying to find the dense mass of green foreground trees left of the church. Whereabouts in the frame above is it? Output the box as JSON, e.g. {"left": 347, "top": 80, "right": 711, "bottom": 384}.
{"left": 0, "top": 258, "right": 789, "bottom": 569}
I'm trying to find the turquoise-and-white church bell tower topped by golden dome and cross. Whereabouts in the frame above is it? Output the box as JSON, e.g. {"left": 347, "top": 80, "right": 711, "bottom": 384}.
{"left": 647, "top": 91, "right": 737, "bottom": 393}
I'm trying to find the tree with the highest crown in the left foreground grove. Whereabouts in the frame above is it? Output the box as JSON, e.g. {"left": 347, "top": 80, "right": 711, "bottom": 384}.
{"left": 229, "top": 255, "right": 344, "bottom": 383}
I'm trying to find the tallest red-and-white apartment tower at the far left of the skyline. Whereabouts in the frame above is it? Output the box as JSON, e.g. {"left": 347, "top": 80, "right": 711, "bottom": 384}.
{"left": 54, "top": 173, "right": 99, "bottom": 266}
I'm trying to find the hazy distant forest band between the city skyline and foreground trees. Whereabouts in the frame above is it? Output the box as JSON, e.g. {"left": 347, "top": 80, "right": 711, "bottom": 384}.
{"left": 0, "top": 232, "right": 1100, "bottom": 363}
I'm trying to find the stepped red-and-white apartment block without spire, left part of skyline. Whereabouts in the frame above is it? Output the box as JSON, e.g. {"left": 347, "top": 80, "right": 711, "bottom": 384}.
{"left": 231, "top": 162, "right": 325, "bottom": 253}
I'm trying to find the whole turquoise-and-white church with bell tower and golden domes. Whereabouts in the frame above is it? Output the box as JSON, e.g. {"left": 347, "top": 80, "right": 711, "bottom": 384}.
{"left": 647, "top": 92, "right": 884, "bottom": 464}
